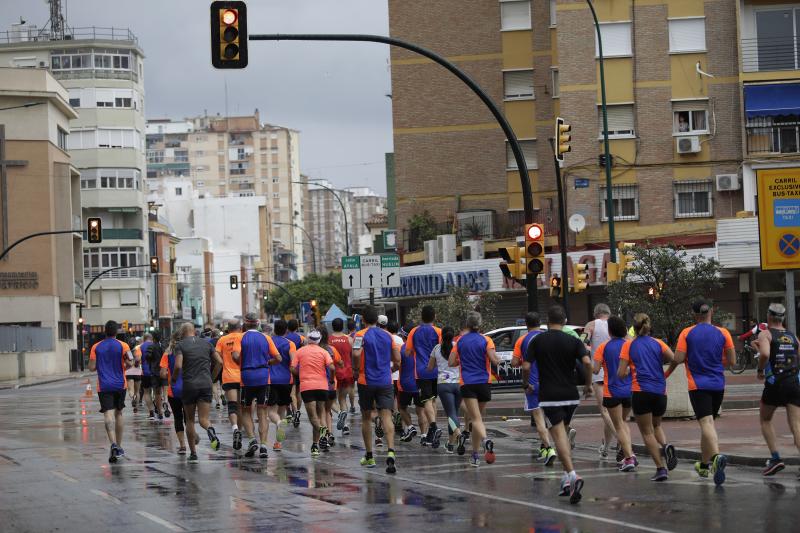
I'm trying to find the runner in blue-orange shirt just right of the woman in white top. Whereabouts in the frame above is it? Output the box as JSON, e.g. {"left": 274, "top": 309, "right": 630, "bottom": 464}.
{"left": 449, "top": 313, "right": 500, "bottom": 467}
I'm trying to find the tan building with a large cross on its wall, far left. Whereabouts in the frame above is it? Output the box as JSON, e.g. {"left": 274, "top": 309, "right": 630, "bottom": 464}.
{"left": 0, "top": 68, "right": 84, "bottom": 379}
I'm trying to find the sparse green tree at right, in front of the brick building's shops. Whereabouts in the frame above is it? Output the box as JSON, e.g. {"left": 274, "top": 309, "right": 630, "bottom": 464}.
{"left": 608, "top": 244, "right": 722, "bottom": 346}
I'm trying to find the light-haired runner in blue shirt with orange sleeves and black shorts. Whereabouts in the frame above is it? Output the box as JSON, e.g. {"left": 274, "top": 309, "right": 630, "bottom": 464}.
{"left": 617, "top": 313, "right": 678, "bottom": 481}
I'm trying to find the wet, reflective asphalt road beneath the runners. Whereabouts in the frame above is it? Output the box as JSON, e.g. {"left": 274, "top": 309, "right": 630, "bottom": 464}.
{"left": 0, "top": 380, "right": 800, "bottom": 533}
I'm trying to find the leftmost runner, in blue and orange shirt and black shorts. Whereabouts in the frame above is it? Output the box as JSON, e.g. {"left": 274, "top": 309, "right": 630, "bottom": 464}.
{"left": 89, "top": 320, "right": 133, "bottom": 463}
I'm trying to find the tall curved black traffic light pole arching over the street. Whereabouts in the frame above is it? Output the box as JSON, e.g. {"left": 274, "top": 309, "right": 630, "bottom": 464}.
{"left": 248, "top": 34, "right": 539, "bottom": 311}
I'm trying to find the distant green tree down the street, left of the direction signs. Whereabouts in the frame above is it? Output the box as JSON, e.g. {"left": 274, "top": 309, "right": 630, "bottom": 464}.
{"left": 264, "top": 272, "right": 347, "bottom": 315}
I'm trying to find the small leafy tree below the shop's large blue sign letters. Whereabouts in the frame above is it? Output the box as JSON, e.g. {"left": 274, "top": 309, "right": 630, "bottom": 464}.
{"left": 408, "top": 287, "right": 500, "bottom": 331}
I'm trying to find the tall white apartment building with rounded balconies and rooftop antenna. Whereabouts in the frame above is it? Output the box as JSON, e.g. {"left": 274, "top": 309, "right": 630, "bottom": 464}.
{"left": 0, "top": 24, "right": 150, "bottom": 331}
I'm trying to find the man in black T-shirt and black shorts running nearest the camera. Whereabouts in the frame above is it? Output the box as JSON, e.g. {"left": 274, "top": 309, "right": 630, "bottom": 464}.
{"left": 525, "top": 305, "right": 592, "bottom": 503}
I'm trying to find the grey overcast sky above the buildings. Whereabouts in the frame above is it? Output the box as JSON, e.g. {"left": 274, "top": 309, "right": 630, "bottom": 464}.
{"left": 0, "top": 0, "right": 392, "bottom": 194}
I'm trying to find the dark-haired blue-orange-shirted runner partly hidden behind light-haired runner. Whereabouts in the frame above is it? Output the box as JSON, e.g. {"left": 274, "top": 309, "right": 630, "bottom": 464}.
{"left": 593, "top": 316, "right": 639, "bottom": 472}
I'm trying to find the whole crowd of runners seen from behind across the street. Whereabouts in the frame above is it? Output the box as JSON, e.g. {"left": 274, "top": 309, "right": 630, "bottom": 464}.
{"left": 90, "top": 299, "right": 800, "bottom": 503}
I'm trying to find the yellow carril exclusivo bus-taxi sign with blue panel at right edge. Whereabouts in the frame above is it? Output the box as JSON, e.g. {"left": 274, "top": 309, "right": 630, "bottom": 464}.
{"left": 756, "top": 168, "right": 800, "bottom": 270}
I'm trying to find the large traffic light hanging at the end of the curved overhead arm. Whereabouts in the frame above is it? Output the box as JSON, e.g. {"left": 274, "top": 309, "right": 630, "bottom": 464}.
{"left": 211, "top": 0, "right": 247, "bottom": 68}
